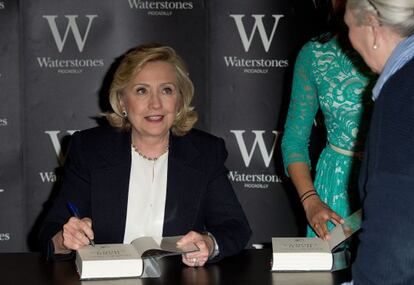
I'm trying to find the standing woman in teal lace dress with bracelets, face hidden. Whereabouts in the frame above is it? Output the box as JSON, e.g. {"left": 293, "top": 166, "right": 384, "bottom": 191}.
{"left": 282, "top": 0, "right": 374, "bottom": 239}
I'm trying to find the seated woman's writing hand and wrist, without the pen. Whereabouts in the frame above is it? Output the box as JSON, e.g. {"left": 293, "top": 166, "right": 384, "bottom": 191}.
{"left": 52, "top": 217, "right": 94, "bottom": 253}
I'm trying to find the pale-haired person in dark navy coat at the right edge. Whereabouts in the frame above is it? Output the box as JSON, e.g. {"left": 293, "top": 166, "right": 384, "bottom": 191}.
{"left": 345, "top": 0, "right": 414, "bottom": 285}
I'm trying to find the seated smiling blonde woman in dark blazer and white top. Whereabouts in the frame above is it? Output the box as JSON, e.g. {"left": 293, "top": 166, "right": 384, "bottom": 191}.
{"left": 41, "top": 44, "right": 251, "bottom": 267}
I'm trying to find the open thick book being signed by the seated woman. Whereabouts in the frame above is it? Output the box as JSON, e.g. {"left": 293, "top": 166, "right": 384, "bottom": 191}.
{"left": 75, "top": 236, "right": 199, "bottom": 279}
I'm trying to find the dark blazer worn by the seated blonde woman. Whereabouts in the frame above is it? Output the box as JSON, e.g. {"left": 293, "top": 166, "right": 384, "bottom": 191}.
{"left": 40, "top": 127, "right": 251, "bottom": 260}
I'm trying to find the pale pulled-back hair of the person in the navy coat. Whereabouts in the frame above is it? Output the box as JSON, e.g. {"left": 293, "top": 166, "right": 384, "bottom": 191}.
{"left": 347, "top": 0, "right": 414, "bottom": 37}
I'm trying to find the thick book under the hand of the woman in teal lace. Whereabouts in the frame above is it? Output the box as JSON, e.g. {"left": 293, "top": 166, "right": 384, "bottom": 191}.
{"left": 272, "top": 210, "right": 362, "bottom": 271}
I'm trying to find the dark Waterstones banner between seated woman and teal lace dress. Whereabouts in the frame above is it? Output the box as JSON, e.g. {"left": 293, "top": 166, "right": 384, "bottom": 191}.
{"left": 209, "top": 0, "right": 312, "bottom": 243}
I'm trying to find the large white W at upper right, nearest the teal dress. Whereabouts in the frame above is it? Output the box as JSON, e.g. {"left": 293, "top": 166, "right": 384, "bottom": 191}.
{"left": 230, "top": 14, "right": 283, "bottom": 52}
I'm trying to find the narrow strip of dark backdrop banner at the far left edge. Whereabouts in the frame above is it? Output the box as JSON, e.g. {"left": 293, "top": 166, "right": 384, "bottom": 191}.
{"left": 0, "top": 1, "right": 26, "bottom": 252}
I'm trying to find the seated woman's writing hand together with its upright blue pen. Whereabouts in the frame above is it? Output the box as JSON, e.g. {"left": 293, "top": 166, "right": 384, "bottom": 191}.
{"left": 63, "top": 202, "right": 95, "bottom": 246}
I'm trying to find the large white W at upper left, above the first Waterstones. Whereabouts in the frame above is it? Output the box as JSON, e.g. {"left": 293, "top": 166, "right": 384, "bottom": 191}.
{"left": 43, "top": 15, "right": 98, "bottom": 52}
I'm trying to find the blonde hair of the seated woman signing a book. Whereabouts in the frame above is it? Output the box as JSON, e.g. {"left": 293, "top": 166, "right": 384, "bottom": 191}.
{"left": 105, "top": 44, "right": 198, "bottom": 136}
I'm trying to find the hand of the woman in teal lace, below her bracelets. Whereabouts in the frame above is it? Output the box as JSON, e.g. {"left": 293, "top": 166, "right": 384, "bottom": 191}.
{"left": 303, "top": 195, "right": 345, "bottom": 240}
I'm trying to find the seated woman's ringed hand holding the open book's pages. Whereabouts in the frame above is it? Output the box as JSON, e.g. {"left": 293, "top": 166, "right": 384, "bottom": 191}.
{"left": 177, "top": 231, "right": 214, "bottom": 267}
